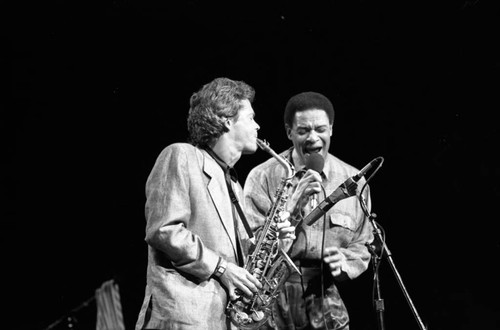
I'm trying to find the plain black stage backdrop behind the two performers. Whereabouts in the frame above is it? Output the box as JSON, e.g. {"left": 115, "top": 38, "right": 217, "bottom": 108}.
{"left": 10, "top": 0, "right": 500, "bottom": 330}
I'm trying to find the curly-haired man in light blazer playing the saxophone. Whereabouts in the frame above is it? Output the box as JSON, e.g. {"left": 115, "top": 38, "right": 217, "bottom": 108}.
{"left": 136, "top": 78, "right": 295, "bottom": 330}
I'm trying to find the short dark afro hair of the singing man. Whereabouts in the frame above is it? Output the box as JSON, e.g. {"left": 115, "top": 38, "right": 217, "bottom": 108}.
{"left": 284, "top": 92, "right": 335, "bottom": 128}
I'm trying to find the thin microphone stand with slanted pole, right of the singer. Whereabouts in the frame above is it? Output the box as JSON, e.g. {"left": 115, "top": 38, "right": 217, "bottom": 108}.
{"left": 359, "top": 196, "right": 427, "bottom": 330}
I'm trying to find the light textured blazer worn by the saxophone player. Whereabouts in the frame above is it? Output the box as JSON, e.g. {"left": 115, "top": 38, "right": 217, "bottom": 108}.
{"left": 136, "top": 143, "right": 249, "bottom": 330}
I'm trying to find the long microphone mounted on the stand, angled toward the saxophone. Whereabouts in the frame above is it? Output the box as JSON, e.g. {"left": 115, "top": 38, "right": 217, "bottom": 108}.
{"left": 304, "top": 157, "right": 381, "bottom": 226}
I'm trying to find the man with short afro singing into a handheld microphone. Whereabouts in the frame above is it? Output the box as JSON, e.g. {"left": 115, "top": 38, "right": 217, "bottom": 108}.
{"left": 244, "top": 92, "right": 373, "bottom": 330}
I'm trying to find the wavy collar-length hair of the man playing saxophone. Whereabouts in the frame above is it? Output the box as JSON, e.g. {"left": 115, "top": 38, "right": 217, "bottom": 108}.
{"left": 187, "top": 78, "right": 255, "bottom": 147}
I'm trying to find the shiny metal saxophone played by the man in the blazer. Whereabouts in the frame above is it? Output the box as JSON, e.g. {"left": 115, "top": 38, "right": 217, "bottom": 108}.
{"left": 226, "top": 139, "right": 300, "bottom": 329}
